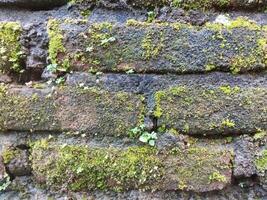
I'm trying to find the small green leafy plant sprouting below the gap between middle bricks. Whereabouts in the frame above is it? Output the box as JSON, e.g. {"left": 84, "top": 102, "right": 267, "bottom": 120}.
{"left": 129, "top": 125, "right": 158, "bottom": 146}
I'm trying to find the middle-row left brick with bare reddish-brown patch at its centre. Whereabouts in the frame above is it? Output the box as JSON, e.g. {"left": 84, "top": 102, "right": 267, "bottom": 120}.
{"left": 0, "top": 86, "right": 144, "bottom": 135}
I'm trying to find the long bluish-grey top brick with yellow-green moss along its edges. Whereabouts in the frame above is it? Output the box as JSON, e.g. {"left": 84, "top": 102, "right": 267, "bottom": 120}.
{"left": 48, "top": 18, "right": 266, "bottom": 73}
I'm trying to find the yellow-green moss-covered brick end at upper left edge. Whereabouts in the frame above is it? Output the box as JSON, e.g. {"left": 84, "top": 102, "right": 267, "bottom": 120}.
{"left": 0, "top": 22, "right": 23, "bottom": 73}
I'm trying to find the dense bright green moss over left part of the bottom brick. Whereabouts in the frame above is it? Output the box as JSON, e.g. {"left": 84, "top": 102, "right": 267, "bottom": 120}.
{"left": 33, "top": 143, "right": 162, "bottom": 191}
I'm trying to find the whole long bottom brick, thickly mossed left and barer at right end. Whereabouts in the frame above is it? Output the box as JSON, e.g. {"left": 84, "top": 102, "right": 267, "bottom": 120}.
{"left": 31, "top": 140, "right": 232, "bottom": 192}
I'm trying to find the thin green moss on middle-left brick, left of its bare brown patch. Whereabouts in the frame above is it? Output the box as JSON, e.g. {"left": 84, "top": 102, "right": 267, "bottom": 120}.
{"left": 0, "top": 86, "right": 58, "bottom": 131}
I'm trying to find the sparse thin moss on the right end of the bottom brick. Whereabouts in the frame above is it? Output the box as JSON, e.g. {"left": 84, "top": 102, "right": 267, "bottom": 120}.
{"left": 173, "top": 147, "right": 231, "bottom": 190}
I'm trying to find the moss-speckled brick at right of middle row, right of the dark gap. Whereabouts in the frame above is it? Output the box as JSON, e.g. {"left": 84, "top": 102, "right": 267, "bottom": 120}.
{"left": 154, "top": 84, "right": 267, "bottom": 135}
